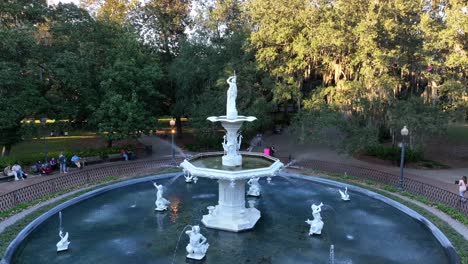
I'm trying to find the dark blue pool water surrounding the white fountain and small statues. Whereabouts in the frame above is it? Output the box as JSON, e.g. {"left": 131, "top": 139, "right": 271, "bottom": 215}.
{"left": 12, "top": 177, "right": 448, "bottom": 264}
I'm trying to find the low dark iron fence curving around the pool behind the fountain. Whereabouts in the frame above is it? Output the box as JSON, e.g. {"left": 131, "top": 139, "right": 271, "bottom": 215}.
{"left": 0, "top": 158, "right": 468, "bottom": 216}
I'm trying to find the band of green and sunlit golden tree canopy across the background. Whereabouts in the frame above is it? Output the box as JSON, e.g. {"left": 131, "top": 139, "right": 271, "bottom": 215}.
{"left": 0, "top": 0, "right": 468, "bottom": 155}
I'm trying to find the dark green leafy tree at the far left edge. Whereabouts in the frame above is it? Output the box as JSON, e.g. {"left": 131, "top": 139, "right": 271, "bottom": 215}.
{"left": 0, "top": 1, "right": 45, "bottom": 155}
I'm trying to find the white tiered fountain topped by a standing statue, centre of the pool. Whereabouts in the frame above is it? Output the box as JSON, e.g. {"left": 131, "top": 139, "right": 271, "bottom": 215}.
{"left": 180, "top": 76, "right": 283, "bottom": 232}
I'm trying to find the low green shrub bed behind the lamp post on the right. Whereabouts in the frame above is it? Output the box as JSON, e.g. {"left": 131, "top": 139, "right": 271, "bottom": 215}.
{"left": 364, "top": 145, "right": 423, "bottom": 163}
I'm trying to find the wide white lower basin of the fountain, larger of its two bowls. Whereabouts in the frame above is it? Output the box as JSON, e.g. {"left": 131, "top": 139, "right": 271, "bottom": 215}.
{"left": 180, "top": 152, "right": 283, "bottom": 181}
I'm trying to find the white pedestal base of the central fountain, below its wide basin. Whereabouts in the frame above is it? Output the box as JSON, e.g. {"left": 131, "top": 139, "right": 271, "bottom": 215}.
{"left": 202, "top": 180, "right": 261, "bottom": 232}
